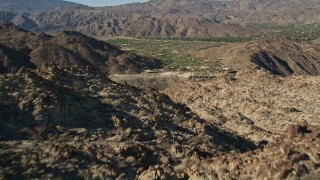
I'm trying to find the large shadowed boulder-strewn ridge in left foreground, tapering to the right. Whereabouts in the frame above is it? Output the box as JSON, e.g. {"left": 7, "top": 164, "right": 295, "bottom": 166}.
{"left": 0, "top": 66, "right": 255, "bottom": 179}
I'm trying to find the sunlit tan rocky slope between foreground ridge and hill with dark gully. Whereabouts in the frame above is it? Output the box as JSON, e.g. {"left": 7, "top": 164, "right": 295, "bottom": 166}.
{"left": 164, "top": 70, "right": 320, "bottom": 141}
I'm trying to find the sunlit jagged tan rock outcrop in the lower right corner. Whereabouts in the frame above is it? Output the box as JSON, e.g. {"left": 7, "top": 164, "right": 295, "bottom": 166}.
{"left": 211, "top": 123, "right": 320, "bottom": 179}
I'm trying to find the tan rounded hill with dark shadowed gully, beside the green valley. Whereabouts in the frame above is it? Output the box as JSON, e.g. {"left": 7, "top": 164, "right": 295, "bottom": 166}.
{"left": 190, "top": 37, "right": 320, "bottom": 76}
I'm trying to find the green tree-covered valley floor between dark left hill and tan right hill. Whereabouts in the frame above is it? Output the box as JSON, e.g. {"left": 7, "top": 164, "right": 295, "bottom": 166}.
{"left": 106, "top": 37, "right": 236, "bottom": 72}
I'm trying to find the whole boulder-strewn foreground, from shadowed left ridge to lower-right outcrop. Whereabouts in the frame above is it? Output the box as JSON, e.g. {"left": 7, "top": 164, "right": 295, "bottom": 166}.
{"left": 0, "top": 63, "right": 320, "bottom": 179}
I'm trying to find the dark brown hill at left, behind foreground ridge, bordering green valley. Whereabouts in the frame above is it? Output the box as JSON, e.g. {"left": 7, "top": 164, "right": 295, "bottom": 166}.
{"left": 0, "top": 24, "right": 161, "bottom": 73}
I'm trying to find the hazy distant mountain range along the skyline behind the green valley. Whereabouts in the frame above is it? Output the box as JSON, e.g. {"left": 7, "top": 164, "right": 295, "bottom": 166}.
{"left": 0, "top": 0, "right": 320, "bottom": 38}
